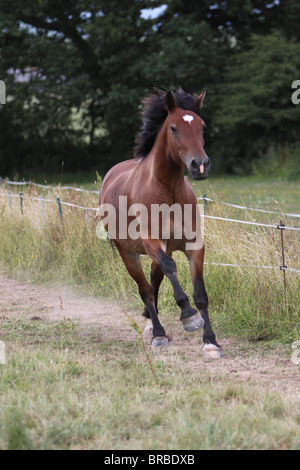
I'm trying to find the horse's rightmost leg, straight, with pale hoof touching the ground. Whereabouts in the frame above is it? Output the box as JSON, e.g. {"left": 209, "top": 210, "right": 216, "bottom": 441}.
{"left": 186, "top": 247, "right": 222, "bottom": 358}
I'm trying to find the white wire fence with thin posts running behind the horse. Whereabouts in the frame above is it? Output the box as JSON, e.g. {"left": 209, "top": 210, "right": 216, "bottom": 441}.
{"left": 0, "top": 177, "right": 300, "bottom": 278}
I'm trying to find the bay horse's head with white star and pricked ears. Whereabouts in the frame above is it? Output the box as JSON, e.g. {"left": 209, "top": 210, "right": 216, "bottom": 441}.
{"left": 165, "top": 90, "right": 210, "bottom": 180}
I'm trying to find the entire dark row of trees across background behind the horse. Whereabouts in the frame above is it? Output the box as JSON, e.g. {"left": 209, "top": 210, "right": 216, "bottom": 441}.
{"left": 0, "top": 0, "right": 300, "bottom": 176}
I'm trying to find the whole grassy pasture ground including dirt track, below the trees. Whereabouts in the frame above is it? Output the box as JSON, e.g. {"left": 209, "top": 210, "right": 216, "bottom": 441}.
{"left": 0, "top": 177, "right": 300, "bottom": 449}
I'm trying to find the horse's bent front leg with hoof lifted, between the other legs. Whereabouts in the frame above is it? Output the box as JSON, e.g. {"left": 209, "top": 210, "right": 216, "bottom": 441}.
{"left": 144, "top": 240, "right": 204, "bottom": 331}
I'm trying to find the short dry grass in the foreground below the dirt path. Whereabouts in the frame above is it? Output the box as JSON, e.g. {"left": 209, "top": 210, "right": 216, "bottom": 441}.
{"left": 0, "top": 319, "right": 300, "bottom": 450}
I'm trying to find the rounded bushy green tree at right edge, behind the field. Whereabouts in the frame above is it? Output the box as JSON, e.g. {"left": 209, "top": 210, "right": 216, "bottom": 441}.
{"left": 214, "top": 31, "right": 300, "bottom": 171}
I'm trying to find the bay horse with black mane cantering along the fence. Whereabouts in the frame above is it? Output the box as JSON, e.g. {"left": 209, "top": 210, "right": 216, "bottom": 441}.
{"left": 99, "top": 88, "right": 222, "bottom": 358}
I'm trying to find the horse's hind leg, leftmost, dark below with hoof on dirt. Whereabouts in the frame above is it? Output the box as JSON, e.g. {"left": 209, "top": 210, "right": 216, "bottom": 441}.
{"left": 116, "top": 248, "right": 169, "bottom": 346}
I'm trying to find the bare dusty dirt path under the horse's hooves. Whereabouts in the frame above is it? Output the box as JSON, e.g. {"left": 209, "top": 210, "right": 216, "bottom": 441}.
{"left": 0, "top": 273, "right": 300, "bottom": 398}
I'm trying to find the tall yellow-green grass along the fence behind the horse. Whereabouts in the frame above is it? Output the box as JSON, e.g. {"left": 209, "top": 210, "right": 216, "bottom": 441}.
{"left": 0, "top": 183, "right": 300, "bottom": 342}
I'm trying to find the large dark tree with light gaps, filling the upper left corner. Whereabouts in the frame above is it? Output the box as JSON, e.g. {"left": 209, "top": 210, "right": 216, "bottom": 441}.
{"left": 0, "top": 0, "right": 152, "bottom": 171}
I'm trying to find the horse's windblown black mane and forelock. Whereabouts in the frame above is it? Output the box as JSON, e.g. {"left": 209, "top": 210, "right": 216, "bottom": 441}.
{"left": 134, "top": 88, "right": 199, "bottom": 158}
